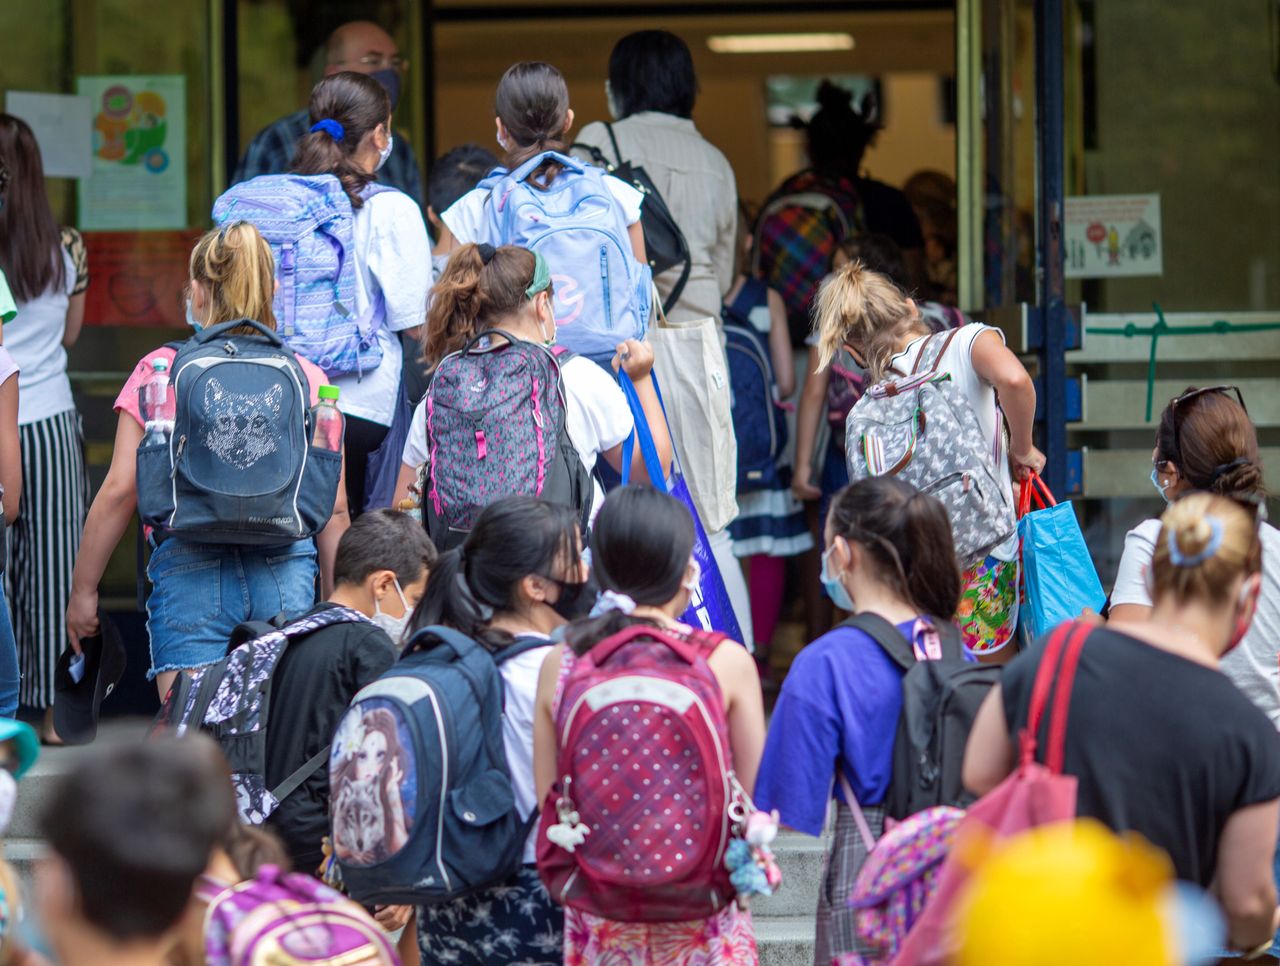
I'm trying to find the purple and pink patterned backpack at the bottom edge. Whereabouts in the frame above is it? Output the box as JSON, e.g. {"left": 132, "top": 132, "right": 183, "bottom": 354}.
{"left": 196, "top": 865, "right": 399, "bottom": 966}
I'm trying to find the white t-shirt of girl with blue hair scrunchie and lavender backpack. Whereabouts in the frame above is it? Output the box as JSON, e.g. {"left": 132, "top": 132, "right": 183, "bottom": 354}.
{"left": 333, "top": 191, "right": 431, "bottom": 426}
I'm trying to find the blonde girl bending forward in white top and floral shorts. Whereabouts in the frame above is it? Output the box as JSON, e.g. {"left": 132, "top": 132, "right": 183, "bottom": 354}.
{"left": 814, "top": 260, "right": 1044, "bottom": 661}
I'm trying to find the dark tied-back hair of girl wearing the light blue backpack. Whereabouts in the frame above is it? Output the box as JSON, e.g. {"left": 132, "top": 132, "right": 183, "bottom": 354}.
{"left": 493, "top": 60, "right": 568, "bottom": 188}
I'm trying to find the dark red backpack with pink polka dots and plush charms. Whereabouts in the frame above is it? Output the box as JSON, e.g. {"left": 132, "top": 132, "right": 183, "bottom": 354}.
{"left": 538, "top": 626, "right": 745, "bottom": 922}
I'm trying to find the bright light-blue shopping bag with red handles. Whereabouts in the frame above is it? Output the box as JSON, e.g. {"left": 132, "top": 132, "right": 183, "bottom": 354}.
{"left": 1018, "top": 475, "right": 1107, "bottom": 640}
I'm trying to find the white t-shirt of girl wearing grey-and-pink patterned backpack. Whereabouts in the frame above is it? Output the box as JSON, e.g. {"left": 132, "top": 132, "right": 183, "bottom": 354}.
{"left": 403, "top": 356, "right": 635, "bottom": 519}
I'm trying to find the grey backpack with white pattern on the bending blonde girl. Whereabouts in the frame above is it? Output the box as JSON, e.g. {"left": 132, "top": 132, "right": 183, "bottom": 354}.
{"left": 845, "top": 329, "right": 1018, "bottom": 568}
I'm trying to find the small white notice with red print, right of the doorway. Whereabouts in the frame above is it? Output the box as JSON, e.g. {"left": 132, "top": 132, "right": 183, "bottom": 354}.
{"left": 1062, "top": 194, "right": 1165, "bottom": 279}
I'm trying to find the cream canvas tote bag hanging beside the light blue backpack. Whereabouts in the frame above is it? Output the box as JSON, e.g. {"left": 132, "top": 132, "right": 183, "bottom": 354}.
{"left": 637, "top": 298, "right": 737, "bottom": 534}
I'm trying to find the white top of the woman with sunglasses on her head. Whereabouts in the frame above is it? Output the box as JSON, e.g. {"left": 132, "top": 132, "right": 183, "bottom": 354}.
{"left": 1111, "top": 519, "right": 1280, "bottom": 728}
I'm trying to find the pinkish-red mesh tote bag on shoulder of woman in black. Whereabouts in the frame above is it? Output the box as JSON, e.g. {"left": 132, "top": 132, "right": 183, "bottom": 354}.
{"left": 891, "top": 623, "right": 1092, "bottom": 966}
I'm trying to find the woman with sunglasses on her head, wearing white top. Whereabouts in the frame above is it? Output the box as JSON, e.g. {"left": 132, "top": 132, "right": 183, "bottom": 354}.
{"left": 1111, "top": 386, "right": 1280, "bottom": 728}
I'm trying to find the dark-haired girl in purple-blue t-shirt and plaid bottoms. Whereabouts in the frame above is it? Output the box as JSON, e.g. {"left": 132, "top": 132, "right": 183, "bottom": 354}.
{"left": 755, "top": 476, "right": 960, "bottom": 962}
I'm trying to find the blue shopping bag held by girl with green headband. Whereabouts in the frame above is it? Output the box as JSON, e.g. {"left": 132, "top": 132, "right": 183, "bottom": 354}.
{"left": 618, "top": 372, "right": 742, "bottom": 641}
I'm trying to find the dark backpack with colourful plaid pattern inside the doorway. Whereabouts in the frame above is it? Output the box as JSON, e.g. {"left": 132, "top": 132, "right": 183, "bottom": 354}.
{"left": 750, "top": 170, "right": 867, "bottom": 345}
